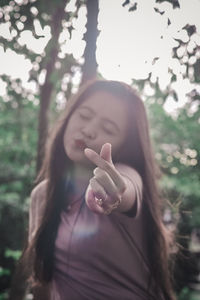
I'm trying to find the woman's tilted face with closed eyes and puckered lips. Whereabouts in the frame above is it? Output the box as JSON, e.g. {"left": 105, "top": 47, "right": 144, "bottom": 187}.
{"left": 64, "top": 91, "right": 128, "bottom": 164}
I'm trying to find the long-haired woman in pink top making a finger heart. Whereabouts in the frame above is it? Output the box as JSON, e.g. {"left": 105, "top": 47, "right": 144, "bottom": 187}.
{"left": 27, "top": 80, "right": 175, "bottom": 300}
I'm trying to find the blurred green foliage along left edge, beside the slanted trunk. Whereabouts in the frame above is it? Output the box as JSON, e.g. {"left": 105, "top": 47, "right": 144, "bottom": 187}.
{"left": 0, "top": 76, "right": 38, "bottom": 299}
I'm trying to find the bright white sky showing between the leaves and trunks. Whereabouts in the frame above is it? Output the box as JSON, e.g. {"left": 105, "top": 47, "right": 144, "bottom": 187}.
{"left": 0, "top": 0, "right": 200, "bottom": 111}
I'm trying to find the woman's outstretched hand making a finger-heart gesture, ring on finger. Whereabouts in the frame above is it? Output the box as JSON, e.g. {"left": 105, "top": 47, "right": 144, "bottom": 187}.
{"left": 84, "top": 143, "right": 126, "bottom": 214}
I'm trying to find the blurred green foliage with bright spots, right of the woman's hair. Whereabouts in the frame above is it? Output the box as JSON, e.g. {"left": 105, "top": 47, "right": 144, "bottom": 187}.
{"left": 149, "top": 98, "right": 200, "bottom": 227}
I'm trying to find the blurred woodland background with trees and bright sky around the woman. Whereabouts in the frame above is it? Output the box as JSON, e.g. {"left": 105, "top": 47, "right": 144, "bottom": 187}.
{"left": 0, "top": 0, "right": 200, "bottom": 300}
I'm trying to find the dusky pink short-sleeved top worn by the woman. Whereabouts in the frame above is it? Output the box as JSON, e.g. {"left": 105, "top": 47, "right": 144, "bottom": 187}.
{"left": 30, "top": 179, "right": 163, "bottom": 300}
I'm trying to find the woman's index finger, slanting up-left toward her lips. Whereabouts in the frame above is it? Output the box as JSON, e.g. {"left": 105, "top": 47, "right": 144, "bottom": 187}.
{"left": 84, "top": 148, "right": 125, "bottom": 193}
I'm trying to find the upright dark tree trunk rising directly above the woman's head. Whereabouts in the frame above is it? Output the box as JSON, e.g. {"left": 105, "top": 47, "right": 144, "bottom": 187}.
{"left": 81, "top": 0, "right": 99, "bottom": 85}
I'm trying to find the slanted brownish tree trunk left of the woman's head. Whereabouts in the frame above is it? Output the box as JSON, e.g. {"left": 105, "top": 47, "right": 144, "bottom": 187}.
{"left": 36, "top": 0, "right": 66, "bottom": 172}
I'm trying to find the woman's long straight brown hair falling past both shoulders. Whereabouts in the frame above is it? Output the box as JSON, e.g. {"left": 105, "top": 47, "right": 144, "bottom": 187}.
{"left": 27, "top": 80, "right": 175, "bottom": 300}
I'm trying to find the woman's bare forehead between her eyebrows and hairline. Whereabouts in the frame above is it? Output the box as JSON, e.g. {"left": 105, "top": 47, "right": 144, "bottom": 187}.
{"left": 80, "top": 91, "right": 128, "bottom": 121}
